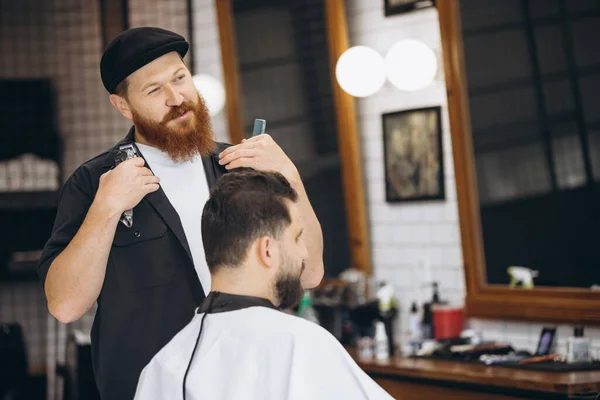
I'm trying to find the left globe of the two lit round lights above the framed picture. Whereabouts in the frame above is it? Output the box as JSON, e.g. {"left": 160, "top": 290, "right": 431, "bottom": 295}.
{"left": 335, "top": 46, "right": 385, "bottom": 97}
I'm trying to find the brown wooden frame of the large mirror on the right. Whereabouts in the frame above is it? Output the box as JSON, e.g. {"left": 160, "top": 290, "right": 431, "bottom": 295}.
{"left": 437, "top": 1, "right": 600, "bottom": 325}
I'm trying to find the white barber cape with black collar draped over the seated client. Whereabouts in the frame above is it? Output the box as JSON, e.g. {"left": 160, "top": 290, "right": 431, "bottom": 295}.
{"left": 135, "top": 292, "right": 392, "bottom": 400}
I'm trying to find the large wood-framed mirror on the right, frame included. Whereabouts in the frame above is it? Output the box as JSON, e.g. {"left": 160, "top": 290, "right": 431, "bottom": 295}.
{"left": 438, "top": 0, "right": 600, "bottom": 324}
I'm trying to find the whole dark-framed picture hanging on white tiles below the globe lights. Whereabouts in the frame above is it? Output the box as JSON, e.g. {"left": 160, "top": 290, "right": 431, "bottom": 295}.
{"left": 382, "top": 106, "right": 445, "bottom": 202}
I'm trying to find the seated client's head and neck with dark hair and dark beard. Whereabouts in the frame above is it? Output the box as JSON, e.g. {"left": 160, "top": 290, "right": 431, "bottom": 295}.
{"left": 202, "top": 171, "right": 308, "bottom": 308}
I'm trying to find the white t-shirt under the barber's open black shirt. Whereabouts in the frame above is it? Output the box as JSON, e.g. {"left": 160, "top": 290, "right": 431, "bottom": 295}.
{"left": 136, "top": 143, "right": 210, "bottom": 294}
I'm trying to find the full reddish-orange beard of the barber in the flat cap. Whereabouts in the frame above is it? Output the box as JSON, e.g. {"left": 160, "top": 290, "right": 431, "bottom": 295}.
{"left": 132, "top": 96, "right": 216, "bottom": 162}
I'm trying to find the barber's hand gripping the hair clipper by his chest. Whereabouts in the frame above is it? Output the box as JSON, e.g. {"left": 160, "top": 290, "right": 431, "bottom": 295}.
{"left": 94, "top": 157, "right": 160, "bottom": 215}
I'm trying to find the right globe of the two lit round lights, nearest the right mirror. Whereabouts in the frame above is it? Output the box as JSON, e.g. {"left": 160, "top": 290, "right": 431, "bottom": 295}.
{"left": 385, "top": 39, "right": 437, "bottom": 91}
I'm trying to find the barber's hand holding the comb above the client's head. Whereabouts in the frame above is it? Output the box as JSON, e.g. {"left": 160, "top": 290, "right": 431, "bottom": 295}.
{"left": 219, "top": 133, "right": 299, "bottom": 183}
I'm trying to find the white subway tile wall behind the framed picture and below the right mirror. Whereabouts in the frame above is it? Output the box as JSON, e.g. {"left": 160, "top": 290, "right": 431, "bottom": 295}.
{"left": 346, "top": 0, "right": 600, "bottom": 356}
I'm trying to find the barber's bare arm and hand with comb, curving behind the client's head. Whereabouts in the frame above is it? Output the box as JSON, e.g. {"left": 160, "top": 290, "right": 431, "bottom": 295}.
{"left": 219, "top": 134, "right": 324, "bottom": 289}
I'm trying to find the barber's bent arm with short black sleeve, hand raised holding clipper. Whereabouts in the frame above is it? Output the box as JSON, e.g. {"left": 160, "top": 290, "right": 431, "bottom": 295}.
{"left": 38, "top": 158, "right": 158, "bottom": 323}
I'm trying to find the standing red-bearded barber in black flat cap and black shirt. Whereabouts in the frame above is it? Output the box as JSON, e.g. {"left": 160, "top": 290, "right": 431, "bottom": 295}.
{"left": 38, "top": 27, "right": 323, "bottom": 400}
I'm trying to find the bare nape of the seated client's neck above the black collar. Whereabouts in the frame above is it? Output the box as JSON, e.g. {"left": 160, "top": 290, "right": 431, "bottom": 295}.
{"left": 210, "top": 267, "right": 277, "bottom": 305}
